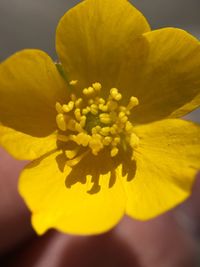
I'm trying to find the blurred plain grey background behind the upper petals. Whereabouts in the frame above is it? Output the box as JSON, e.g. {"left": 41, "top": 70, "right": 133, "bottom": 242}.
{"left": 0, "top": 0, "right": 200, "bottom": 121}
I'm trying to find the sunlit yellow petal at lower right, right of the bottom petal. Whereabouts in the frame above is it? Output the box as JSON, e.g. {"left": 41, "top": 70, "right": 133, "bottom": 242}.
{"left": 124, "top": 119, "right": 200, "bottom": 220}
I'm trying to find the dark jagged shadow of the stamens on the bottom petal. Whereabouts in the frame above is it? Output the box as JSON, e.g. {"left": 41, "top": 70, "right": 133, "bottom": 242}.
{"left": 56, "top": 150, "right": 136, "bottom": 194}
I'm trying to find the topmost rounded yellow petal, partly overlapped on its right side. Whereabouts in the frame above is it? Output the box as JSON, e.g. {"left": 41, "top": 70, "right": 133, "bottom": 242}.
{"left": 56, "top": 0, "right": 150, "bottom": 91}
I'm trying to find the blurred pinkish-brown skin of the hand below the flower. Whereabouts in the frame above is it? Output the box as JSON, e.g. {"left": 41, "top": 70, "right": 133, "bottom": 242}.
{"left": 0, "top": 149, "right": 200, "bottom": 267}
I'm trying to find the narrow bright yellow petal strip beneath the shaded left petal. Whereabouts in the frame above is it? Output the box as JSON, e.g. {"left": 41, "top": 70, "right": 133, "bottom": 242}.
{"left": 0, "top": 125, "right": 57, "bottom": 160}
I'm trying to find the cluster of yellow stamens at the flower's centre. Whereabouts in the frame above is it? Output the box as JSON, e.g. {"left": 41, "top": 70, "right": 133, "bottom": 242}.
{"left": 56, "top": 81, "right": 139, "bottom": 164}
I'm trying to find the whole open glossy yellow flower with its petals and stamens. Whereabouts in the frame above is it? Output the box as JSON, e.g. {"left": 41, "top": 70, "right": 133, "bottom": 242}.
{"left": 0, "top": 0, "right": 200, "bottom": 234}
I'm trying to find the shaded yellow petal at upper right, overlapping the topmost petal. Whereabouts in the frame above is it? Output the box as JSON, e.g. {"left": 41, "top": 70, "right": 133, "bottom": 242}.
{"left": 118, "top": 28, "right": 200, "bottom": 123}
